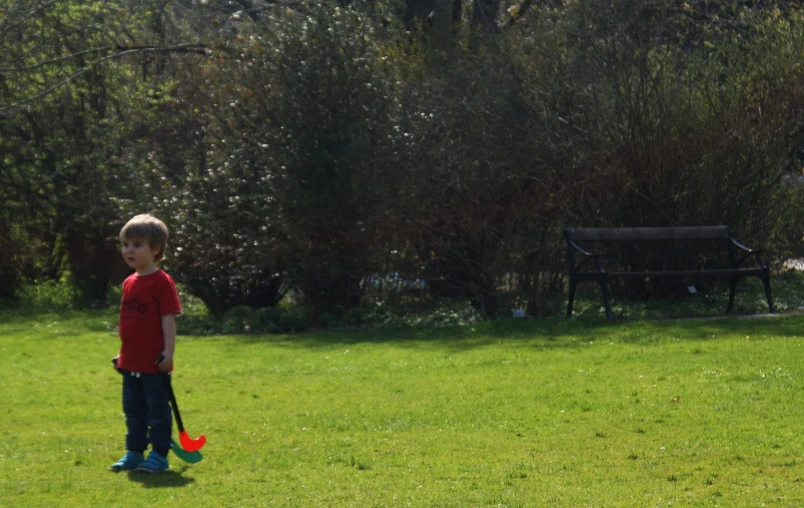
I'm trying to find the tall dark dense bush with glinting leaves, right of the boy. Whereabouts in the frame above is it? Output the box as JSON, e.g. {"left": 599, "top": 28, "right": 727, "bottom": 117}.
{"left": 199, "top": 2, "right": 402, "bottom": 315}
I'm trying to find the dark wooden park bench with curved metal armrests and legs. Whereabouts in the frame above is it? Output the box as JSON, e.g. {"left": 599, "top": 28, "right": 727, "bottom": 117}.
{"left": 564, "top": 226, "right": 775, "bottom": 320}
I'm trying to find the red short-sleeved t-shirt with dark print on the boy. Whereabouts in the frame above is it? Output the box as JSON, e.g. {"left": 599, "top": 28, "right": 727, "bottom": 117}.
{"left": 117, "top": 270, "right": 181, "bottom": 374}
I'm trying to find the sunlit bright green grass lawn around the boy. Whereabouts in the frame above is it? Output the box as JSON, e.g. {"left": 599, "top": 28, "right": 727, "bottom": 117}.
{"left": 0, "top": 311, "right": 804, "bottom": 507}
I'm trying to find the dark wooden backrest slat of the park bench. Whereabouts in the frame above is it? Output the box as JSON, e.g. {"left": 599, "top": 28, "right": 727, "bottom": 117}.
{"left": 564, "top": 226, "right": 731, "bottom": 242}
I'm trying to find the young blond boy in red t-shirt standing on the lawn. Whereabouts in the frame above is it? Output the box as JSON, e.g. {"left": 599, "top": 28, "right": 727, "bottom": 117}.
{"left": 109, "top": 215, "right": 181, "bottom": 473}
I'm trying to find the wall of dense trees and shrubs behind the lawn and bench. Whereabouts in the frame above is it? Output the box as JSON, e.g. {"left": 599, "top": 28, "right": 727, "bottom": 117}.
{"left": 0, "top": 0, "right": 804, "bottom": 325}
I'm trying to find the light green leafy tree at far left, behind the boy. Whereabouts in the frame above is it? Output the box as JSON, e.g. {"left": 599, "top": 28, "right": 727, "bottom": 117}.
{"left": 0, "top": 0, "right": 209, "bottom": 302}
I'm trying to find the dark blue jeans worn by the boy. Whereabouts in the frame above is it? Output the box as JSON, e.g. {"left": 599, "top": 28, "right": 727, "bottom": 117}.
{"left": 121, "top": 371, "right": 173, "bottom": 454}
